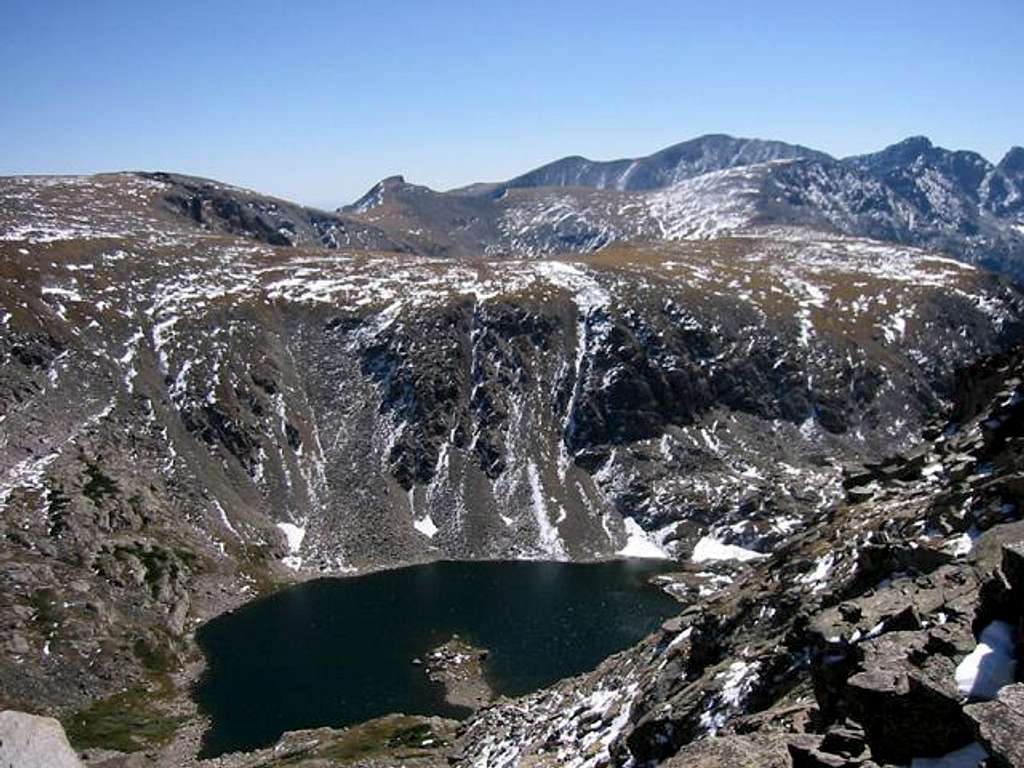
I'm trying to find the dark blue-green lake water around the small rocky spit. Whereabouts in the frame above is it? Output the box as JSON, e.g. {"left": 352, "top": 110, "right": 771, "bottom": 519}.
{"left": 195, "top": 560, "right": 679, "bottom": 757}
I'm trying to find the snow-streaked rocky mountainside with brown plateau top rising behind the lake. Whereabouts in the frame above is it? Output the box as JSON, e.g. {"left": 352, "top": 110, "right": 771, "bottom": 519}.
{"left": 0, "top": 175, "right": 1021, "bottom": 765}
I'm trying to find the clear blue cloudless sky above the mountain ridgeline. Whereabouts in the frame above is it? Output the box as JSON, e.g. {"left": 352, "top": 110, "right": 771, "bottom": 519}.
{"left": 0, "top": 0, "right": 1024, "bottom": 207}
